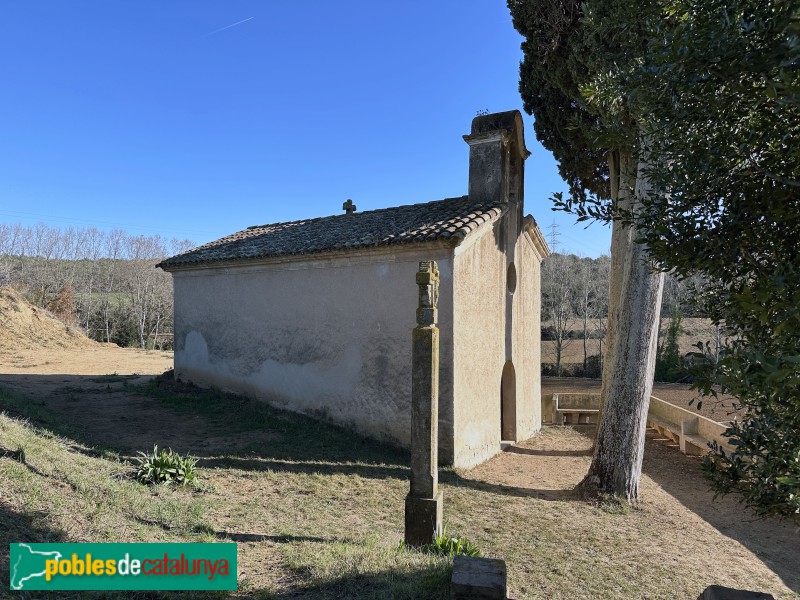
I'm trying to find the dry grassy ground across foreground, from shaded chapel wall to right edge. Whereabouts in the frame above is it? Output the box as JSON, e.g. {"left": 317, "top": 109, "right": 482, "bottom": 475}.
{"left": 0, "top": 376, "right": 800, "bottom": 598}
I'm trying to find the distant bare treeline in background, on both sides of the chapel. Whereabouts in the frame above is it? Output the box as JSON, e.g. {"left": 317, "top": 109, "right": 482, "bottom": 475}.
{"left": 0, "top": 224, "right": 703, "bottom": 366}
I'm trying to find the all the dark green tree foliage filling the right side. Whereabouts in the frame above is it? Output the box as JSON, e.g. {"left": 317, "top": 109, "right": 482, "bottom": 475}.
{"left": 509, "top": 0, "right": 800, "bottom": 519}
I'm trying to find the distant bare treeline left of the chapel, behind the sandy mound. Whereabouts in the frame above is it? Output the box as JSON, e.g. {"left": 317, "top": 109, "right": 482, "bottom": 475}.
{"left": 0, "top": 224, "right": 193, "bottom": 348}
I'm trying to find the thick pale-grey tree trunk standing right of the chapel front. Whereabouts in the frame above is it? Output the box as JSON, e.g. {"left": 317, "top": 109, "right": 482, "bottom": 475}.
{"left": 581, "top": 153, "right": 664, "bottom": 502}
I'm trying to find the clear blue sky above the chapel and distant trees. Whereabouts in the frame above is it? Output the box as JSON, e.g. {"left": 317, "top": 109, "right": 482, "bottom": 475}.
{"left": 0, "top": 0, "right": 610, "bottom": 256}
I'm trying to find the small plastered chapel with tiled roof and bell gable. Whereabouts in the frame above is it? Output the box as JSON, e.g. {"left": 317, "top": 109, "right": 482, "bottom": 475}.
{"left": 159, "top": 111, "right": 549, "bottom": 467}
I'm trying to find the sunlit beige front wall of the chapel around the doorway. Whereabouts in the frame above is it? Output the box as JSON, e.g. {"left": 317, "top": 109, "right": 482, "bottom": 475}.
{"left": 453, "top": 213, "right": 541, "bottom": 467}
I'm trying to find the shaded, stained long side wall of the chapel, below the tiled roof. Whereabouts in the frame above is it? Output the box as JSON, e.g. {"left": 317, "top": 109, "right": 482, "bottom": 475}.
{"left": 173, "top": 244, "right": 453, "bottom": 462}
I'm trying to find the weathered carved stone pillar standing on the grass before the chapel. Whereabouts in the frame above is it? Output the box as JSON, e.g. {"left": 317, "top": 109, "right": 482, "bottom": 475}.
{"left": 405, "top": 261, "right": 442, "bottom": 546}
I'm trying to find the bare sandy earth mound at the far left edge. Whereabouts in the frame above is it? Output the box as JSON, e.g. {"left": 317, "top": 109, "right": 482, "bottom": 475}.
{"left": 0, "top": 287, "right": 101, "bottom": 351}
